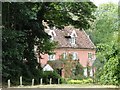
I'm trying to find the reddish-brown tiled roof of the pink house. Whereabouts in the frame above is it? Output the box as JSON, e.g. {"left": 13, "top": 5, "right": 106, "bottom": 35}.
{"left": 45, "top": 26, "right": 95, "bottom": 49}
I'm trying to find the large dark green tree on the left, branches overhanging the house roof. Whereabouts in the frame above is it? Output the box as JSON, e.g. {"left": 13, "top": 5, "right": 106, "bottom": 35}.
{"left": 2, "top": 2, "right": 96, "bottom": 84}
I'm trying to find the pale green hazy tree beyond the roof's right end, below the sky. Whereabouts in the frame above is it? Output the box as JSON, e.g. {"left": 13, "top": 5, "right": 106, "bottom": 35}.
{"left": 87, "top": 3, "right": 119, "bottom": 45}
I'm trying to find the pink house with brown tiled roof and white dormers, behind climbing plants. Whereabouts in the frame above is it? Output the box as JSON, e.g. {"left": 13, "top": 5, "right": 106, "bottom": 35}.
{"left": 36, "top": 26, "right": 95, "bottom": 77}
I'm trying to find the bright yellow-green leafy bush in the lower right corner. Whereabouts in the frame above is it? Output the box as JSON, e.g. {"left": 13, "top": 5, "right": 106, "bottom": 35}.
{"left": 100, "top": 57, "right": 120, "bottom": 85}
